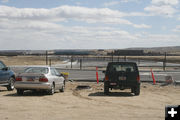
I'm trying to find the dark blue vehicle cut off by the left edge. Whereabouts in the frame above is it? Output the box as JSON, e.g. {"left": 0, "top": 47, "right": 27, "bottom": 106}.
{"left": 0, "top": 61, "right": 15, "bottom": 91}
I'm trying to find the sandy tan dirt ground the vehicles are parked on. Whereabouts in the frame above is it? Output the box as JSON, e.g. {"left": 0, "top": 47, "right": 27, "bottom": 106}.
{"left": 0, "top": 82, "right": 180, "bottom": 120}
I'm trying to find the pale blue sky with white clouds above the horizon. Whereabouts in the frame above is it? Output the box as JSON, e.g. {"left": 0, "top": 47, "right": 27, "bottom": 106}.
{"left": 0, "top": 0, "right": 180, "bottom": 50}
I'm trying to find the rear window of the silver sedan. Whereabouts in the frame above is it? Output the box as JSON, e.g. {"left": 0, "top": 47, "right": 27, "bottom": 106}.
{"left": 24, "top": 67, "right": 48, "bottom": 74}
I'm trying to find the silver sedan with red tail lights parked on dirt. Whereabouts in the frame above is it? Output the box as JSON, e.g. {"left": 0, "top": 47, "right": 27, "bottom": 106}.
{"left": 14, "top": 67, "right": 65, "bottom": 95}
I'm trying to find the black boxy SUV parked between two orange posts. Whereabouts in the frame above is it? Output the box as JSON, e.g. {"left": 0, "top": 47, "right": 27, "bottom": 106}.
{"left": 103, "top": 62, "right": 140, "bottom": 95}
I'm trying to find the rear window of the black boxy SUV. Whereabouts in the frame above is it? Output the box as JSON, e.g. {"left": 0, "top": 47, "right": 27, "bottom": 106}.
{"left": 108, "top": 64, "right": 137, "bottom": 72}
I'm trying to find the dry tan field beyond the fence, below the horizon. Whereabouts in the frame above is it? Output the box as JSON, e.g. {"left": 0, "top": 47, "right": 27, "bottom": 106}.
{"left": 0, "top": 56, "right": 180, "bottom": 66}
